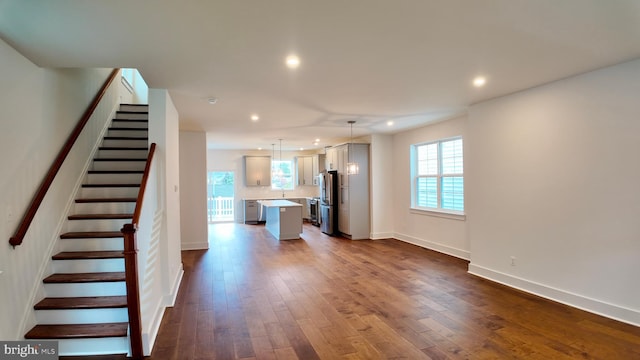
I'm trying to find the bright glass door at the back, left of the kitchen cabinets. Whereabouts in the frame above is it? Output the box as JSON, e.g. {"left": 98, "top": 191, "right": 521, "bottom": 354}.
{"left": 207, "top": 171, "right": 235, "bottom": 224}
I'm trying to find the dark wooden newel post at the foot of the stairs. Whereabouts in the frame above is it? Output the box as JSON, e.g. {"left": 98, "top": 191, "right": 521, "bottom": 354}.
{"left": 121, "top": 224, "right": 143, "bottom": 359}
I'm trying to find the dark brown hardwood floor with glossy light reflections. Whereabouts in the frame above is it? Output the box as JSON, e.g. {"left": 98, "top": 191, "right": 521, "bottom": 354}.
{"left": 149, "top": 224, "right": 640, "bottom": 360}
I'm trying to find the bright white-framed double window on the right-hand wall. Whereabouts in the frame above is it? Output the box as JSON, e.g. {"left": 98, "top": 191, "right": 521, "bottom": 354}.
{"left": 411, "top": 138, "right": 464, "bottom": 213}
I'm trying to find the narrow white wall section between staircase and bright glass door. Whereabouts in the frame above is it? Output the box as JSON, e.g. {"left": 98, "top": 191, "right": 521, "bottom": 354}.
{"left": 180, "top": 131, "right": 209, "bottom": 250}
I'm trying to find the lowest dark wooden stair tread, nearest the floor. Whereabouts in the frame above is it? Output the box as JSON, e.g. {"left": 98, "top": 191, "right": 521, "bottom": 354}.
{"left": 24, "top": 323, "right": 129, "bottom": 339}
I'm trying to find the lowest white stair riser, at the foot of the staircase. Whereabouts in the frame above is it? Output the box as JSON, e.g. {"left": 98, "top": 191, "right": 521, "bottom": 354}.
{"left": 58, "top": 336, "right": 129, "bottom": 356}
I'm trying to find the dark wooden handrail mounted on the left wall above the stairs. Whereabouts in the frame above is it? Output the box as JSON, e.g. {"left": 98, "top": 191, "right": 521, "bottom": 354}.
{"left": 9, "top": 69, "right": 120, "bottom": 247}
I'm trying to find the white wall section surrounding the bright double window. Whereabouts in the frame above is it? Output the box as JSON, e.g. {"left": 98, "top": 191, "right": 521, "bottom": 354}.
{"left": 390, "top": 116, "right": 470, "bottom": 259}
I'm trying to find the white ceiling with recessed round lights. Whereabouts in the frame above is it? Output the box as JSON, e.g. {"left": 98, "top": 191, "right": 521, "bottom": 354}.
{"left": 0, "top": 0, "right": 640, "bottom": 150}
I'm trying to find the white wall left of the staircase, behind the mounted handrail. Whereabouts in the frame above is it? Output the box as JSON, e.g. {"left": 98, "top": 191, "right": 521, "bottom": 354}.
{"left": 0, "top": 40, "right": 118, "bottom": 340}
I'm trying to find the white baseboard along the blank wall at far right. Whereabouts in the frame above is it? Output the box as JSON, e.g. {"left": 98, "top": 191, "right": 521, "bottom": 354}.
{"left": 469, "top": 264, "right": 640, "bottom": 326}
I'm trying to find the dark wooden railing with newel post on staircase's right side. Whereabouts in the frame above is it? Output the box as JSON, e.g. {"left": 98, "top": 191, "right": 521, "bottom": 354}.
{"left": 121, "top": 143, "right": 156, "bottom": 359}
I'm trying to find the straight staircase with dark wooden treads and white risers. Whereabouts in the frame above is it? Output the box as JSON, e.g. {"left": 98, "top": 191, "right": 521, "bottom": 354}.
{"left": 25, "top": 105, "right": 149, "bottom": 356}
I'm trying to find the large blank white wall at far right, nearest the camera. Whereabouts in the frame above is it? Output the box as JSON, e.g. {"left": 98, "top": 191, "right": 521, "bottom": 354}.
{"left": 465, "top": 60, "right": 640, "bottom": 325}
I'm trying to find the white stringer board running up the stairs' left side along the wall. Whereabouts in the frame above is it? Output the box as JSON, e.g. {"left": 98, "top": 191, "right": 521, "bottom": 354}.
{"left": 18, "top": 103, "right": 120, "bottom": 344}
